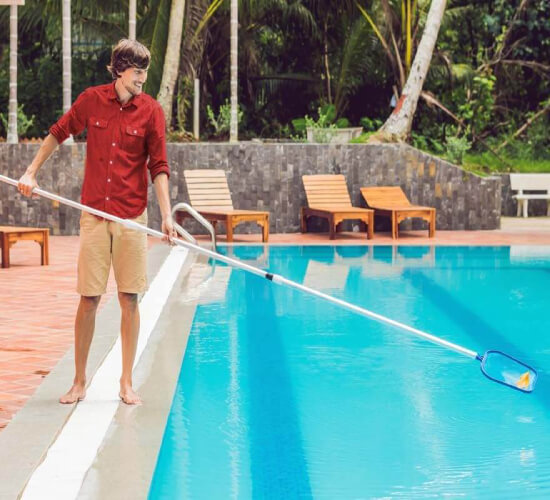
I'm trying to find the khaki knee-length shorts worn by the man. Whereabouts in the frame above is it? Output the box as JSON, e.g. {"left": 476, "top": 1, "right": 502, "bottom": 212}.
{"left": 76, "top": 209, "right": 147, "bottom": 297}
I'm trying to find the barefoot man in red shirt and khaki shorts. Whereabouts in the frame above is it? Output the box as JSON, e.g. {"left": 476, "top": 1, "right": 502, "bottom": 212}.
{"left": 18, "top": 40, "right": 176, "bottom": 405}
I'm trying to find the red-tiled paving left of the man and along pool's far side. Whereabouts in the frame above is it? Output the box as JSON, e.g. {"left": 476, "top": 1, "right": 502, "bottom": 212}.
{"left": 0, "top": 218, "right": 550, "bottom": 430}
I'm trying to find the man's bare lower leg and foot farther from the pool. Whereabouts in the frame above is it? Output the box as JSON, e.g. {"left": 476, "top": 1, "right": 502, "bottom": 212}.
{"left": 59, "top": 296, "right": 101, "bottom": 404}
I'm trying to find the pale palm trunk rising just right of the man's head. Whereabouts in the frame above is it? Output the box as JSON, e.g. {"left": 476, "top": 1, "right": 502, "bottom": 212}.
{"left": 157, "top": 0, "right": 185, "bottom": 129}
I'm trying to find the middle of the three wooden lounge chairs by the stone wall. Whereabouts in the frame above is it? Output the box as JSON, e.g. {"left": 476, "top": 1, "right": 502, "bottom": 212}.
{"left": 300, "top": 175, "right": 374, "bottom": 240}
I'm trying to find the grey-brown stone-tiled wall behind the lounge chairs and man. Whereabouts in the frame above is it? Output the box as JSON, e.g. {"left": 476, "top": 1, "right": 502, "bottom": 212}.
{"left": 0, "top": 143, "right": 501, "bottom": 234}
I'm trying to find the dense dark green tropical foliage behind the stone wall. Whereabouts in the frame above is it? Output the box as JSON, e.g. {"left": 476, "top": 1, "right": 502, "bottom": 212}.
{"left": 0, "top": 0, "right": 550, "bottom": 149}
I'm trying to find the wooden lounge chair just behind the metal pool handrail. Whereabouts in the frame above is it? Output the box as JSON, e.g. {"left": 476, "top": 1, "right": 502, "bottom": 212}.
{"left": 176, "top": 169, "right": 269, "bottom": 243}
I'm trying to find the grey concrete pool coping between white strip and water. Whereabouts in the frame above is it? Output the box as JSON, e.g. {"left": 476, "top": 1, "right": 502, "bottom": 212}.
{"left": 76, "top": 253, "right": 207, "bottom": 500}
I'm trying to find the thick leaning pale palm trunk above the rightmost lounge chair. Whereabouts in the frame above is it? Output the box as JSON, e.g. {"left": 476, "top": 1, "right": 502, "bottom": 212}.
{"left": 380, "top": 0, "right": 447, "bottom": 141}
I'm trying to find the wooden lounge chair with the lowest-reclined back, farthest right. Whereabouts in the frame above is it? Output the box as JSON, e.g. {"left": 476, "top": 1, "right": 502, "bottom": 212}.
{"left": 361, "top": 186, "right": 435, "bottom": 239}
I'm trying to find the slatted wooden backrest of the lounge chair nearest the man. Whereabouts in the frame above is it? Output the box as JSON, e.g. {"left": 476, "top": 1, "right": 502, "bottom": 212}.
{"left": 183, "top": 170, "right": 233, "bottom": 212}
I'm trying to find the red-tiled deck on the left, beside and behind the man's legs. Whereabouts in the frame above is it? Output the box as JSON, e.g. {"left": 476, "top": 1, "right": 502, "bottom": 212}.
{"left": 0, "top": 236, "right": 115, "bottom": 429}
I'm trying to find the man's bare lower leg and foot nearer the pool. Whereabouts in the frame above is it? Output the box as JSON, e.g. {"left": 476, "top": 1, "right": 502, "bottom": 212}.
{"left": 118, "top": 292, "right": 141, "bottom": 405}
